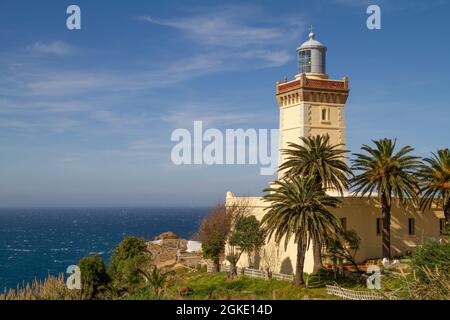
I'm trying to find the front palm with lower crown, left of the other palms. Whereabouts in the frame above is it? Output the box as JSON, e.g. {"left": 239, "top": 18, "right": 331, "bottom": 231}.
{"left": 261, "top": 176, "right": 340, "bottom": 285}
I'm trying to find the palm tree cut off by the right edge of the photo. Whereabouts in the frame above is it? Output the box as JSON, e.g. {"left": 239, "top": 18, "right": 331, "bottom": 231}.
{"left": 419, "top": 149, "right": 450, "bottom": 229}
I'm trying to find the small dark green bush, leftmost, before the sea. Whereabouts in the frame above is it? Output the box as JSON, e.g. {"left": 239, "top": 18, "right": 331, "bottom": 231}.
{"left": 78, "top": 256, "right": 109, "bottom": 299}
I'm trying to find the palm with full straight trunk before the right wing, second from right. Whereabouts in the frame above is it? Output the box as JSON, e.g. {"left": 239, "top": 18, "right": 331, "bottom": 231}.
{"left": 351, "top": 139, "right": 422, "bottom": 258}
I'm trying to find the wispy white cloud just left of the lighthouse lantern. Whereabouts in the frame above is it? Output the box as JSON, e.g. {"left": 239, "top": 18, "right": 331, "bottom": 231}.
{"left": 139, "top": 6, "right": 305, "bottom": 69}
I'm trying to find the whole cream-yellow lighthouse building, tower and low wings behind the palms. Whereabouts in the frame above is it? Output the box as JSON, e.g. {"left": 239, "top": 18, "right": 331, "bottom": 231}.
{"left": 226, "top": 32, "right": 444, "bottom": 273}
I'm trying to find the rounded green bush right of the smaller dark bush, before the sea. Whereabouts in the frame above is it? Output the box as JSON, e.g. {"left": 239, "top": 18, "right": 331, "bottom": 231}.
{"left": 109, "top": 237, "right": 151, "bottom": 289}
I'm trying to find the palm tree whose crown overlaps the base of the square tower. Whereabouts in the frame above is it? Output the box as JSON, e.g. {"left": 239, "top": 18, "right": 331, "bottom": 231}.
{"left": 280, "top": 135, "right": 351, "bottom": 271}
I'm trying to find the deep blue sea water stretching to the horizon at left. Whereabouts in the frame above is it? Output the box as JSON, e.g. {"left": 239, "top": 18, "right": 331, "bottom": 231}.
{"left": 0, "top": 208, "right": 210, "bottom": 291}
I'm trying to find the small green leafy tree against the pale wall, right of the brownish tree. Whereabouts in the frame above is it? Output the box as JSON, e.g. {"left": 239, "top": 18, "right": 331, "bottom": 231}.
{"left": 227, "top": 216, "right": 264, "bottom": 278}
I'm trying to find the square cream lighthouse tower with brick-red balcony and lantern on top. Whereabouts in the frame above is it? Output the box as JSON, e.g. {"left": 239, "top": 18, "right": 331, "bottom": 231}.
{"left": 276, "top": 31, "right": 349, "bottom": 176}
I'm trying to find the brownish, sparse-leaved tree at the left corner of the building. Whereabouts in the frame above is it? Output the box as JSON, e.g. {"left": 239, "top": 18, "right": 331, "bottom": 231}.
{"left": 198, "top": 203, "right": 248, "bottom": 272}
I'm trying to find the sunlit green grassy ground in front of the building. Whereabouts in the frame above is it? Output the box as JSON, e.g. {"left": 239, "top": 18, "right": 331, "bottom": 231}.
{"left": 126, "top": 270, "right": 366, "bottom": 300}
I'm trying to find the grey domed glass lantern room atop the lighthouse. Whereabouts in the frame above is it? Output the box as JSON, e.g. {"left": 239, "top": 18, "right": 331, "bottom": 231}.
{"left": 297, "top": 27, "right": 327, "bottom": 78}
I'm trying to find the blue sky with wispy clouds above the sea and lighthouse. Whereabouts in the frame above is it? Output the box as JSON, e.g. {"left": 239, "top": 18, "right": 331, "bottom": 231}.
{"left": 0, "top": 0, "right": 450, "bottom": 206}
